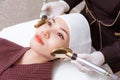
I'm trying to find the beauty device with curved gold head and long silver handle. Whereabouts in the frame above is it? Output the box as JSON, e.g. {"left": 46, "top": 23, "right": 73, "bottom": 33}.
{"left": 51, "top": 48, "right": 110, "bottom": 76}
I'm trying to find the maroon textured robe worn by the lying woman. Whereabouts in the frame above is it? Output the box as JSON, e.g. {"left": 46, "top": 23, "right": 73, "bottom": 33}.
{"left": 0, "top": 38, "right": 52, "bottom": 80}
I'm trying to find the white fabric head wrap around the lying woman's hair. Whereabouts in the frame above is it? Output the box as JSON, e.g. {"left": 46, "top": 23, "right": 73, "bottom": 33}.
{"left": 58, "top": 13, "right": 91, "bottom": 53}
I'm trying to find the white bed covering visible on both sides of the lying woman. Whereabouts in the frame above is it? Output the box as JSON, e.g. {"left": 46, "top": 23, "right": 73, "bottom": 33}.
{"left": 0, "top": 19, "right": 109, "bottom": 80}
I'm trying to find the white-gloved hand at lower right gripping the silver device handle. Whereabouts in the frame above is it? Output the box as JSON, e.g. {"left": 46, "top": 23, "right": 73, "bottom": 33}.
{"left": 71, "top": 51, "right": 105, "bottom": 72}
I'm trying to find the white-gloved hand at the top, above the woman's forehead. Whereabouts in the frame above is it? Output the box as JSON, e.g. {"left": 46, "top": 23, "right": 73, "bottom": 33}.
{"left": 40, "top": 1, "right": 69, "bottom": 18}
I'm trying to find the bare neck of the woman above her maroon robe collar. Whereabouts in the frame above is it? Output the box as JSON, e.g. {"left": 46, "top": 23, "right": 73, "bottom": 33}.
{"left": 16, "top": 49, "right": 49, "bottom": 64}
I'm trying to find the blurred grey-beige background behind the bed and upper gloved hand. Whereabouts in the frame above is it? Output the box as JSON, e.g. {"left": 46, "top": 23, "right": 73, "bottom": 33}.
{"left": 0, "top": 0, "right": 84, "bottom": 30}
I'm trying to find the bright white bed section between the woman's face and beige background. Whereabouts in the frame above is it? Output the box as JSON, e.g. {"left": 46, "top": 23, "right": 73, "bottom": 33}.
{"left": 0, "top": 19, "right": 38, "bottom": 47}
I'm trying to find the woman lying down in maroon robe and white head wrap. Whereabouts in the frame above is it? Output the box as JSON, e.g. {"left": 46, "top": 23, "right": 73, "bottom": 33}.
{"left": 0, "top": 13, "right": 91, "bottom": 80}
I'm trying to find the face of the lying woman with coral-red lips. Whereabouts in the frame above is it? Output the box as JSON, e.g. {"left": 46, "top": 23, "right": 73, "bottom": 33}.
{"left": 30, "top": 18, "right": 69, "bottom": 59}
